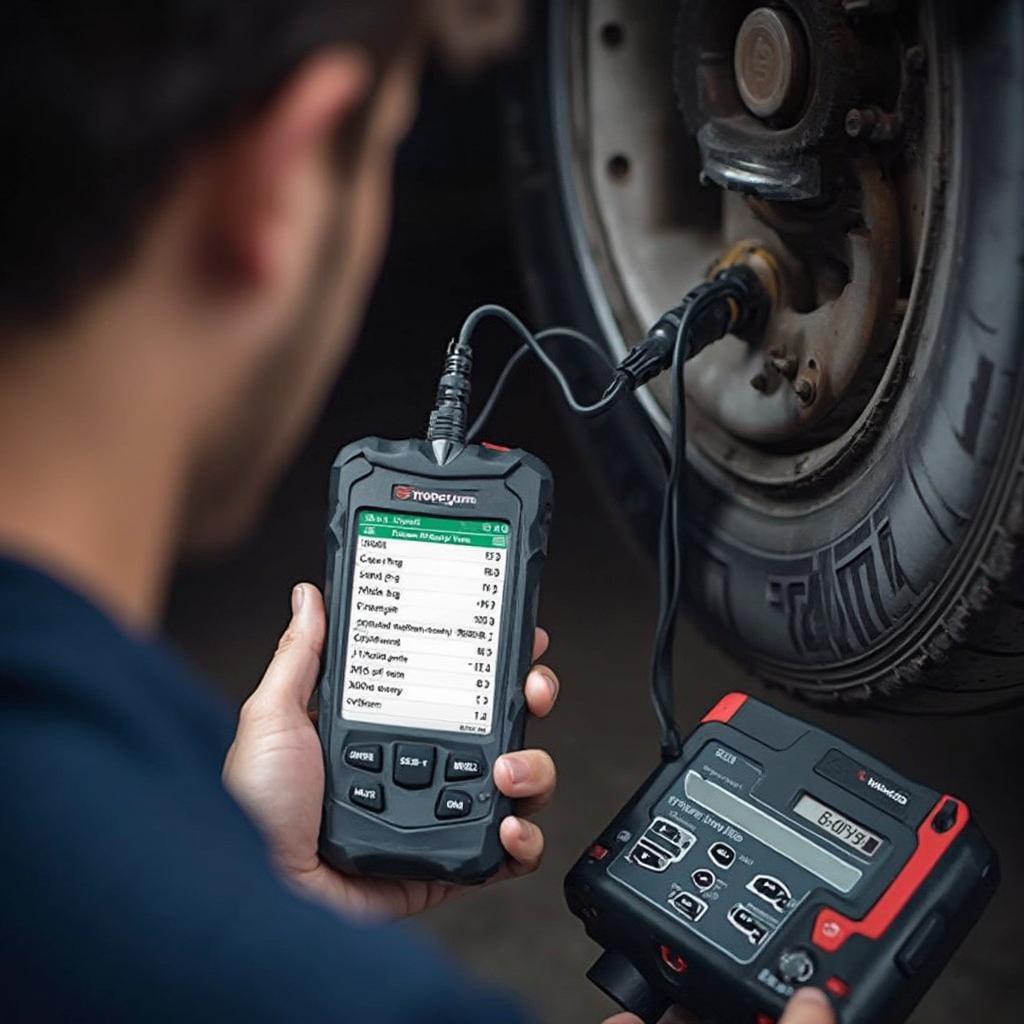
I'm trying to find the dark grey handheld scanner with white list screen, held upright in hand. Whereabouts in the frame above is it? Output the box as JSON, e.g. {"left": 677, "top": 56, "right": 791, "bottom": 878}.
{"left": 318, "top": 438, "right": 552, "bottom": 883}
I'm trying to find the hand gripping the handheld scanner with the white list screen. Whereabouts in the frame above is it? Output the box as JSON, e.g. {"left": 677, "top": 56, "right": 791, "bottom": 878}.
{"left": 223, "top": 584, "right": 558, "bottom": 918}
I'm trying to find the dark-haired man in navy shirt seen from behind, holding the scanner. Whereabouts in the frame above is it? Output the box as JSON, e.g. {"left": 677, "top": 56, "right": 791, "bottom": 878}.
{"left": 0, "top": 6, "right": 829, "bottom": 1024}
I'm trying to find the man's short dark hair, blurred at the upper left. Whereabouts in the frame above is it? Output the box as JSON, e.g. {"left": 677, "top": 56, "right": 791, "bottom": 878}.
{"left": 0, "top": 0, "right": 416, "bottom": 329}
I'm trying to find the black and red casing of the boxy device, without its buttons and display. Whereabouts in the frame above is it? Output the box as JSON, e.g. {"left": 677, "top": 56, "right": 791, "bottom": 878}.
{"left": 565, "top": 693, "right": 998, "bottom": 1024}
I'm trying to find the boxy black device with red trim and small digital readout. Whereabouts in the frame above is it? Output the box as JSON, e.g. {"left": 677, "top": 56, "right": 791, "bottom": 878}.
{"left": 565, "top": 693, "right": 998, "bottom": 1024}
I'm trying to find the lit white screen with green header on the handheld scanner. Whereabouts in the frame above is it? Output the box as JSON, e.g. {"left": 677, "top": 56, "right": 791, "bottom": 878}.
{"left": 341, "top": 509, "right": 510, "bottom": 735}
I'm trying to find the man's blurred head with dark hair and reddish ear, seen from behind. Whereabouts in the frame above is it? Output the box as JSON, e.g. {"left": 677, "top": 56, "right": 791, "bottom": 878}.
{"left": 0, "top": 0, "right": 520, "bottom": 544}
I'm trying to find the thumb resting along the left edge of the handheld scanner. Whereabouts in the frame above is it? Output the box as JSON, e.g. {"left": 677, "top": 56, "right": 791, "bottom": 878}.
{"left": 253, "top": 583, "right": 327, "bottom": 712}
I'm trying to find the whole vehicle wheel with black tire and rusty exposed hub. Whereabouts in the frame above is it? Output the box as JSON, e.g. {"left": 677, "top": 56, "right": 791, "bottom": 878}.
{"left": 508, "top": 0, "right": 1024, "bottom": 714}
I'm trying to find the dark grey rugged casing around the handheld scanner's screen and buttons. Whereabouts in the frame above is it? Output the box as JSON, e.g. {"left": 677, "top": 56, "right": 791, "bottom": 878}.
{"left": 318, "top": 437, "right": 553, "bottom": 884}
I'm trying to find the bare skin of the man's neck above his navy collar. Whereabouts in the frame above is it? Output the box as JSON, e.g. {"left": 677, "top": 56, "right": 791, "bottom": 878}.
{"left": 0, "top": 319, "right": 186, "bottom": 629}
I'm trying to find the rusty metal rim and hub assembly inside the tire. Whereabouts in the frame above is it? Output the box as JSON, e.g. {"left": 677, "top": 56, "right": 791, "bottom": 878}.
{"left": 553, "top": 0, "right": 944, "bottom": 489}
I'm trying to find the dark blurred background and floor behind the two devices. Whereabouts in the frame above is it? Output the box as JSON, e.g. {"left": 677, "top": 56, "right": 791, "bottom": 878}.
{"left": 168, "top": 68, "right": 1024, "bottom": 1024}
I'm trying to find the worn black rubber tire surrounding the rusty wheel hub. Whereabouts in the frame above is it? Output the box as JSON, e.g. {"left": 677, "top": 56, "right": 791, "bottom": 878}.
{"left": 508, "top": 0, "right": 1024, "bottom": 714}
